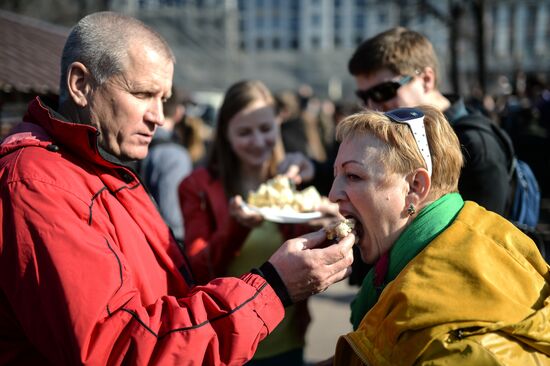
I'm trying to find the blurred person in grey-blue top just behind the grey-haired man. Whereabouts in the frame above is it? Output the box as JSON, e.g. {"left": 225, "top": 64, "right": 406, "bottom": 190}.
{"left": 138, "top": 87, "right": 193, "bottom": 242}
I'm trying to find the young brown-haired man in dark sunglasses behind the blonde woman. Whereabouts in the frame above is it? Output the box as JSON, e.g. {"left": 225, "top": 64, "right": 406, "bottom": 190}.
{"left": 348, "top": 27, "right": 510, "bottom": 219}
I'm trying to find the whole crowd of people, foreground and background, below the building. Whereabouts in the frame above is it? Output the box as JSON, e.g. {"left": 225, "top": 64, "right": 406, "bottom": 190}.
{"left": 0, "top": 12, "right": 550, "bottom": 366}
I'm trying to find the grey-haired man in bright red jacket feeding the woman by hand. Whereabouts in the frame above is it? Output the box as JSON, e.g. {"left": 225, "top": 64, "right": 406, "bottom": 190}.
{"left": 0, "top": 12, "right": 354, "bottom": 365}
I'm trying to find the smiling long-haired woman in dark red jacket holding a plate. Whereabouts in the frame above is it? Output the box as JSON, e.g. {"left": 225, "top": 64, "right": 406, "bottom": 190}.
{"left": 179, "top": 80, "right": 326, "bottom": 365}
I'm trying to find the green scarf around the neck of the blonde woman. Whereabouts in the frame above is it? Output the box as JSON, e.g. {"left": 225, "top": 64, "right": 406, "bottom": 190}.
{"left": 351, "top": 193, "right": 464, "bottom": 330}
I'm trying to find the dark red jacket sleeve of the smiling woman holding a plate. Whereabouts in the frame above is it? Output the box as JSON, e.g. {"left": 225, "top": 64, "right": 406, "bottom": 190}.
{"left": 179, "top": 170, "right": 250, "bottom": 284}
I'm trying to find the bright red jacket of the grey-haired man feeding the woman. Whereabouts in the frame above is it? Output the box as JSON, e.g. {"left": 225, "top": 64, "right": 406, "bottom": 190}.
{"left": 0, "top": 99, "right": 284, "bottom": 365}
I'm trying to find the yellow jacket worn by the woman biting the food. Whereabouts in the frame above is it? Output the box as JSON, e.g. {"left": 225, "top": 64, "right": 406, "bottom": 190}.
{"left": 335, "top": 202, "right": 550, "bottom": 366}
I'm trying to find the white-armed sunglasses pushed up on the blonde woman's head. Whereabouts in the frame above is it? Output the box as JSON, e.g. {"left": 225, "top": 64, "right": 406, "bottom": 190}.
{"left": 384, "top": 108, "right": 432, "bottom": 177}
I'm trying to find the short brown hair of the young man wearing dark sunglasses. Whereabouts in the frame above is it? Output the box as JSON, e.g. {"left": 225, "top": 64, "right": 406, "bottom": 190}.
{"left": 348, "top": 27, "right": 438, "bottom": 86}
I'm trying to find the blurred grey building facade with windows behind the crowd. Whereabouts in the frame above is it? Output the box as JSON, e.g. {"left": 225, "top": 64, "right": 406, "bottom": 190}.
{"left": 4, "top": 0, "right": 550, "bottom": 98}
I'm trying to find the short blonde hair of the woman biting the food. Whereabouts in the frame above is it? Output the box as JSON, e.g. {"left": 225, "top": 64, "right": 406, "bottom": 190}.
{"left": 336, "top": 106, "right": 463, "bottom": 199}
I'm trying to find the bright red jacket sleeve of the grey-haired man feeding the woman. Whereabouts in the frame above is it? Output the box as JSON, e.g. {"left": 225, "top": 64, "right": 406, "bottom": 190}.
{"left": 0, "top": 176, "right": 284, "bottom": 365}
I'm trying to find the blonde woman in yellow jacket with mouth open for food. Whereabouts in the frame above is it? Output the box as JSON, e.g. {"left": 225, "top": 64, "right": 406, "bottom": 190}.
{"left": 329, "top": 107, "right": 550, "bottom": 366}
